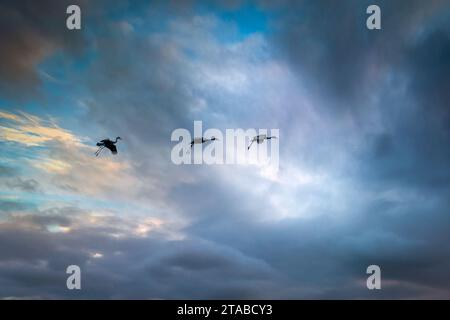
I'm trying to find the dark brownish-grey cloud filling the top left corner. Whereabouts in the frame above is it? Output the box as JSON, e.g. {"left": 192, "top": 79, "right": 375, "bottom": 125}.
{"left": 0, "top": 0, "right": 86, "bottom": 98}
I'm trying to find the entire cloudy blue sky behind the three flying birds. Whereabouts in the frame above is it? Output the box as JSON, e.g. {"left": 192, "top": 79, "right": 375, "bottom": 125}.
{"left": 0, "top": 0, "right": 450, "bottom": 299}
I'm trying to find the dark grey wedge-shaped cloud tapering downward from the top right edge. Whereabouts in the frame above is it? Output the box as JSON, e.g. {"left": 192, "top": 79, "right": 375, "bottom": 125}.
{"left": 268, "top": 0, "right": 445, "bottom": 111}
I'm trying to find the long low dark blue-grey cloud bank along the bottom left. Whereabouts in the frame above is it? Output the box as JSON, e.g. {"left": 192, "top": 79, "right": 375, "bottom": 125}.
{"left": 0, "top": 209, "right": 276, "bottom": 298}
